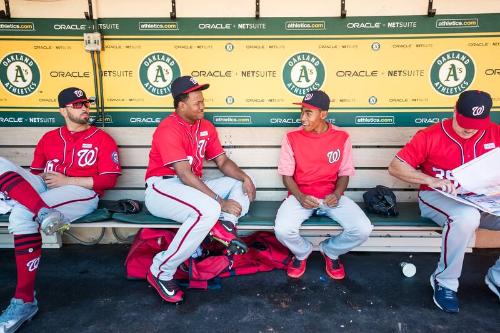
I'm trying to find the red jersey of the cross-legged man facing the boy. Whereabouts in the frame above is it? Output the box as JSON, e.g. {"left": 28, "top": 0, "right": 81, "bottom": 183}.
{"left": 146, "top": 113, "right": 224, "bottom": 179}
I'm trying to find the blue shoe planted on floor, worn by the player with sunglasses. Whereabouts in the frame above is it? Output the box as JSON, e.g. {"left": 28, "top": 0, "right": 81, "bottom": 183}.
{"left": 0, "top": 298, "right": 38, "bottom": 333}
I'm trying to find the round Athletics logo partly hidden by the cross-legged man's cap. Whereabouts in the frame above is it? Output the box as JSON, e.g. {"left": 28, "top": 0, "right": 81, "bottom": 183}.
{"left": 139, "top": 52, "right": 181, "bottom": 96}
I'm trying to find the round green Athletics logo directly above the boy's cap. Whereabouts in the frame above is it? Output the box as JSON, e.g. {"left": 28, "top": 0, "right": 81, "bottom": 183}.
{"left": 283, "top": 52, "right": 325, "bottom": 96}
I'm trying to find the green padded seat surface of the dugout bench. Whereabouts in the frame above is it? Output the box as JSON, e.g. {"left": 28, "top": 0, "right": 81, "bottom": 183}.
{"left": 113, "top": 201, "right": 441, "bottom": 231}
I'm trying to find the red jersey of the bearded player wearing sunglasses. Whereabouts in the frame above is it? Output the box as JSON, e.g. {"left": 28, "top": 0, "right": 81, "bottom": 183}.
{"left": 31, "top": 126, "right": 121, "bottom": 195}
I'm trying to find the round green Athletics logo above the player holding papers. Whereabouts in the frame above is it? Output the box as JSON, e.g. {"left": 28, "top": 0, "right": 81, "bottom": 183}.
{"left": 431, "top": 51, "right": 475, "bottom": 96}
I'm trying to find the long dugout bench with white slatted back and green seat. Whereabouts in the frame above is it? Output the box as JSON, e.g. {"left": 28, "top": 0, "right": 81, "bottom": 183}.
{"left": 0, "top": 127, "right": 490, "bottom": 252}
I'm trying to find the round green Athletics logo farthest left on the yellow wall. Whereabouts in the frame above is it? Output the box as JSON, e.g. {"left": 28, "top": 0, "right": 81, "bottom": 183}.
{"left": 0, "top": 52, "right": 40, "bottom": 96}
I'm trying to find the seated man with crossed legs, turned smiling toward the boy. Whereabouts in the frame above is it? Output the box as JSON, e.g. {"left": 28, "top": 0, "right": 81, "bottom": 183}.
{"left": 145, "top": 76, "right": 255, "bottom": 303}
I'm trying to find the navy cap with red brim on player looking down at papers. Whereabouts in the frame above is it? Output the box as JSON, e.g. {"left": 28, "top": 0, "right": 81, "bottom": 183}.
{"left": 455, "top": 90, "right": 493, "bottom": 129}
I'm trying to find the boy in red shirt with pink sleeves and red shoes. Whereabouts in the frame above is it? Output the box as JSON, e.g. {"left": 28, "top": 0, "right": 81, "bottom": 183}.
{"left": 274, "top": 90, "right": 372, "bottom": 280}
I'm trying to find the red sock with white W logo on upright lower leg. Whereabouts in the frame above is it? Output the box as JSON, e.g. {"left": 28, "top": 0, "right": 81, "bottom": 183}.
{"left": 14, "top": 233, "right": 42, "bottom": 302}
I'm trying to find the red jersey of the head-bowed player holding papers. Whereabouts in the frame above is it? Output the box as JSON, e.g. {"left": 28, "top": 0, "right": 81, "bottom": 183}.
{"left": 396, "top": 119, "right": 500, "bottom": 190}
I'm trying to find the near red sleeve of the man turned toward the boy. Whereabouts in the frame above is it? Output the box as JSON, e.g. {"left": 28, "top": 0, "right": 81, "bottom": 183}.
{"left": 153, "top": 127, "right": 188, "bottom": 166}
